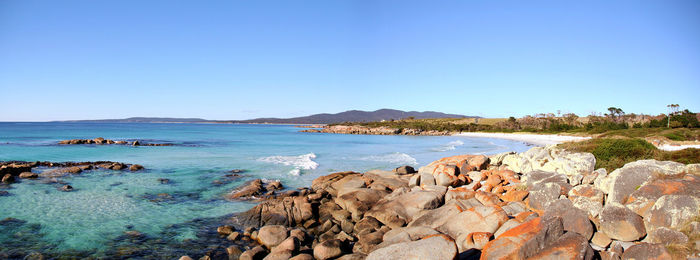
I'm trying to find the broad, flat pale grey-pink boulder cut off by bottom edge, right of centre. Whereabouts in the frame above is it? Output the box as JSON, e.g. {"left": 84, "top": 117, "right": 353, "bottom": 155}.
{"left": 366, "top": 234, "right": 457, "bottom": 260}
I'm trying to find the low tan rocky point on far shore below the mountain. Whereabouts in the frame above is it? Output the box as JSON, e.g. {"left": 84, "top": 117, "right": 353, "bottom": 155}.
{"left": 301, "top": 125, "right": 452, "bottom": 136}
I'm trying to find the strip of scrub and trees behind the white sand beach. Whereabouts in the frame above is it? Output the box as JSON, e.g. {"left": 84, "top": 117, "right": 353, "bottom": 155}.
{"left": 333, "top": 107, "right": 700, "bottom": 141}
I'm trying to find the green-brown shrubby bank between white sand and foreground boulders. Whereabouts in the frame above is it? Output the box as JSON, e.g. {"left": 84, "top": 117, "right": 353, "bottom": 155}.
{"left": 559, "top": 137, "right": 700, "bottom": 171}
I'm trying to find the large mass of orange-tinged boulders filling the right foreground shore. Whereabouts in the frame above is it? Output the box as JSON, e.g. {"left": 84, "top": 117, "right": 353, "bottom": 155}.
{"left": 180, "top": 146, "right": 700, "bottom": 260}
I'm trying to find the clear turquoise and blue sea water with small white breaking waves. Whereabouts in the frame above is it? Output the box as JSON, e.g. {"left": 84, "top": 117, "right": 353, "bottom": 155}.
{"left": 0, "top": 123, "right": 529, "bottom": 258}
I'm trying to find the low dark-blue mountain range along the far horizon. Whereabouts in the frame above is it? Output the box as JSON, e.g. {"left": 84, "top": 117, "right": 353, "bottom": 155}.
{"left": 61, "top": 109, "right": 477, "bottom": 124}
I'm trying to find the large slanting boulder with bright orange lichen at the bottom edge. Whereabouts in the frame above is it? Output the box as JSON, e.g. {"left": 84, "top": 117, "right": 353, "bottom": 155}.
{"left": 481, "top": 216, "right": 564, "bottom": 259}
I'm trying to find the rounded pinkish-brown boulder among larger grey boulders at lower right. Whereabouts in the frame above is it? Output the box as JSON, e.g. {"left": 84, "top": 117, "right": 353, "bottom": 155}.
{"left": 599, "top": 203, "right": 646, "bottom": 241}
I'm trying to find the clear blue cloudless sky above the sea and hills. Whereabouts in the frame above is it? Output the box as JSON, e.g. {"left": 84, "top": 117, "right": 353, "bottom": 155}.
{"left": 0, "top": 0, "right": 700, "bottom": 121}
